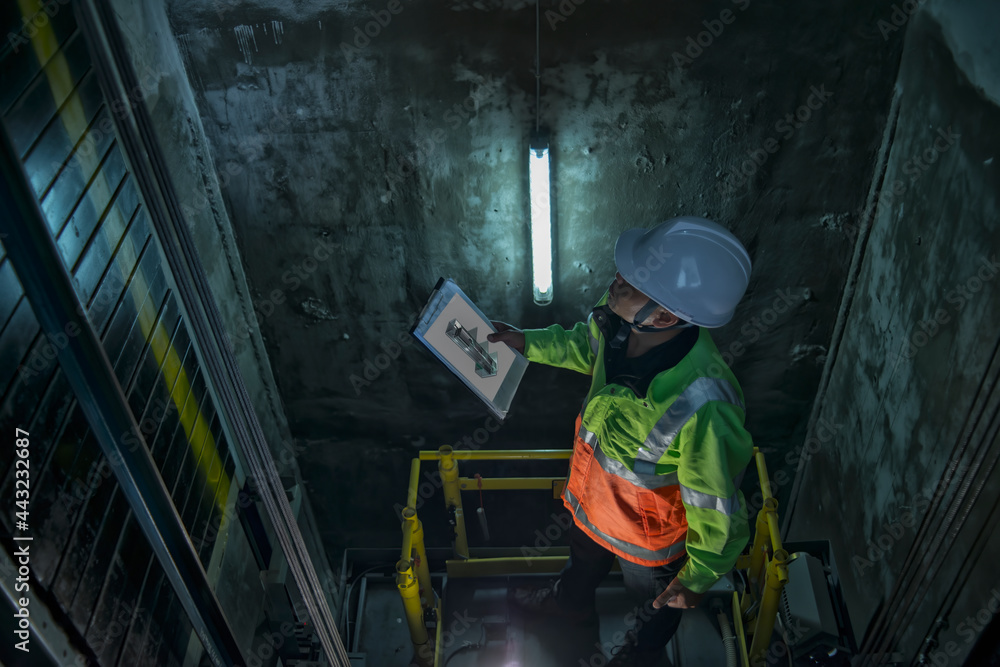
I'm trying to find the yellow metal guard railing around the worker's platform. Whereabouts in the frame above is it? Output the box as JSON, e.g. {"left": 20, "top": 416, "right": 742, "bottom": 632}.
{"left": 396, "top": 445, "right": 789, "bottom": 667}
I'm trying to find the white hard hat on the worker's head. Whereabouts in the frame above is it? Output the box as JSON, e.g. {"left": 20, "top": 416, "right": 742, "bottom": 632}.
{"left": 615, "top": 216, "right": 750, "bottom": 327}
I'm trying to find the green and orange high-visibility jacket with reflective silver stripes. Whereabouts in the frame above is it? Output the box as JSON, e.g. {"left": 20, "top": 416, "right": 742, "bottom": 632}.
{"left": 524, "top": 294, "right": 753, "bottom": 593}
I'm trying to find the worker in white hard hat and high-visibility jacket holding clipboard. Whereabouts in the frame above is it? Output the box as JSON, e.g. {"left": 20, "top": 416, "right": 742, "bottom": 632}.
{"left": 489, "top": 217, "right": 753, "bottom": 667}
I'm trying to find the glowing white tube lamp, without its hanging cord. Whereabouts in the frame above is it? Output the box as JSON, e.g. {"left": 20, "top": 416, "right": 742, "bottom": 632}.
{"left": 528, "top": 137, "right": 552, "bottom": 306}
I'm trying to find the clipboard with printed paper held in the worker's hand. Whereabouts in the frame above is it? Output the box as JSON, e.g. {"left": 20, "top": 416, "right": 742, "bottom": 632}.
{"left": 411, "top": 278, "right": 528, "bottom": 420}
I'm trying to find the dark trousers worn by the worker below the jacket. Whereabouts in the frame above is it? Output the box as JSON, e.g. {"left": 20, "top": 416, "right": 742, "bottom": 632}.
{"left": 559, "top": 524, "right": 687, "bottom": 651}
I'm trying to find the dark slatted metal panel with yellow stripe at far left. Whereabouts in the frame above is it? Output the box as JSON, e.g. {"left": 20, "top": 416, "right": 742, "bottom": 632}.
{"left": 0, "top": 3, "right": 235, "bottom": 665}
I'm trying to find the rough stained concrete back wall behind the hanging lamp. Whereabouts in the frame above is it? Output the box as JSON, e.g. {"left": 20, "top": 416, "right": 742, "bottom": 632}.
{"left": 160, "top": 0, "right": 902, "bottom": 564}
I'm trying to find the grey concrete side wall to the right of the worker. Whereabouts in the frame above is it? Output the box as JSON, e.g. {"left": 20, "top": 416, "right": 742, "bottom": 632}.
{"left": 790, "top": 0, "right": 1000, "bottom": 665}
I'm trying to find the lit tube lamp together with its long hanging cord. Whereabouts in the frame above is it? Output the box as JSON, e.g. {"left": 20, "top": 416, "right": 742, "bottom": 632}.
{"left": 528, "top": 0, "right": 552, "bottom": 306}
